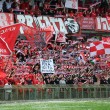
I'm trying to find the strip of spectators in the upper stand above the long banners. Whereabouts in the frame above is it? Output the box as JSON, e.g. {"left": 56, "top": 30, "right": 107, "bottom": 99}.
{"left": 0, "top": 0, "right": 110, "bottom": 17}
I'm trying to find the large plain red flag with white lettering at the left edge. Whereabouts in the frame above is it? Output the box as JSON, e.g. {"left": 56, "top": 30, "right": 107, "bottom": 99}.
{"left": 0, "top": 24, "right": 21, "bottom": 56}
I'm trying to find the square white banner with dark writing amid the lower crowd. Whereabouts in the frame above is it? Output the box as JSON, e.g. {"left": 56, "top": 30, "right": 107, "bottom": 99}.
{"left": 40, "top": 59, "right": 55, "bottom": 73}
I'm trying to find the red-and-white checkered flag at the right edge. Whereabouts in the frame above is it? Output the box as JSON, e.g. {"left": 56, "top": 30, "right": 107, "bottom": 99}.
{"left": 90, "top": 41, "right": 110, "bottom": 56}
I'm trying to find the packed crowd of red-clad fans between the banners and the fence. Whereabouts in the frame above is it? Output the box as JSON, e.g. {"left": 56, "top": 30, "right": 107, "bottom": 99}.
{"left": 0, "top": 39, "right": 110, "bottom": 85}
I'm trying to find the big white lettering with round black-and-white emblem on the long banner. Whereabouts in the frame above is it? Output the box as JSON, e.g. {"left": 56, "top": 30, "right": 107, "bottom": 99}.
{"left": 16, "top": 15, "right": 80, "bottom": 34}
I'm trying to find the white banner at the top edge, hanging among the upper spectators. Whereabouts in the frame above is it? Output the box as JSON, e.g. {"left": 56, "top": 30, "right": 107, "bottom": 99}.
{"left": 65, "top": 0, "right": 78, "bottom": 9}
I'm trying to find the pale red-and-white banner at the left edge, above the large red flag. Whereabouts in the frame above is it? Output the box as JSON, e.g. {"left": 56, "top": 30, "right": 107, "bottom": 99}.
{"left": 0, "top": 13, "right": 14, "bottom": 28}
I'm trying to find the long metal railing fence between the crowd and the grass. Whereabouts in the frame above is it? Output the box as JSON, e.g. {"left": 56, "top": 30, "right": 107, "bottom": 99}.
{"left": 0, "top": 85, "right": 110, "bottom": 101}
